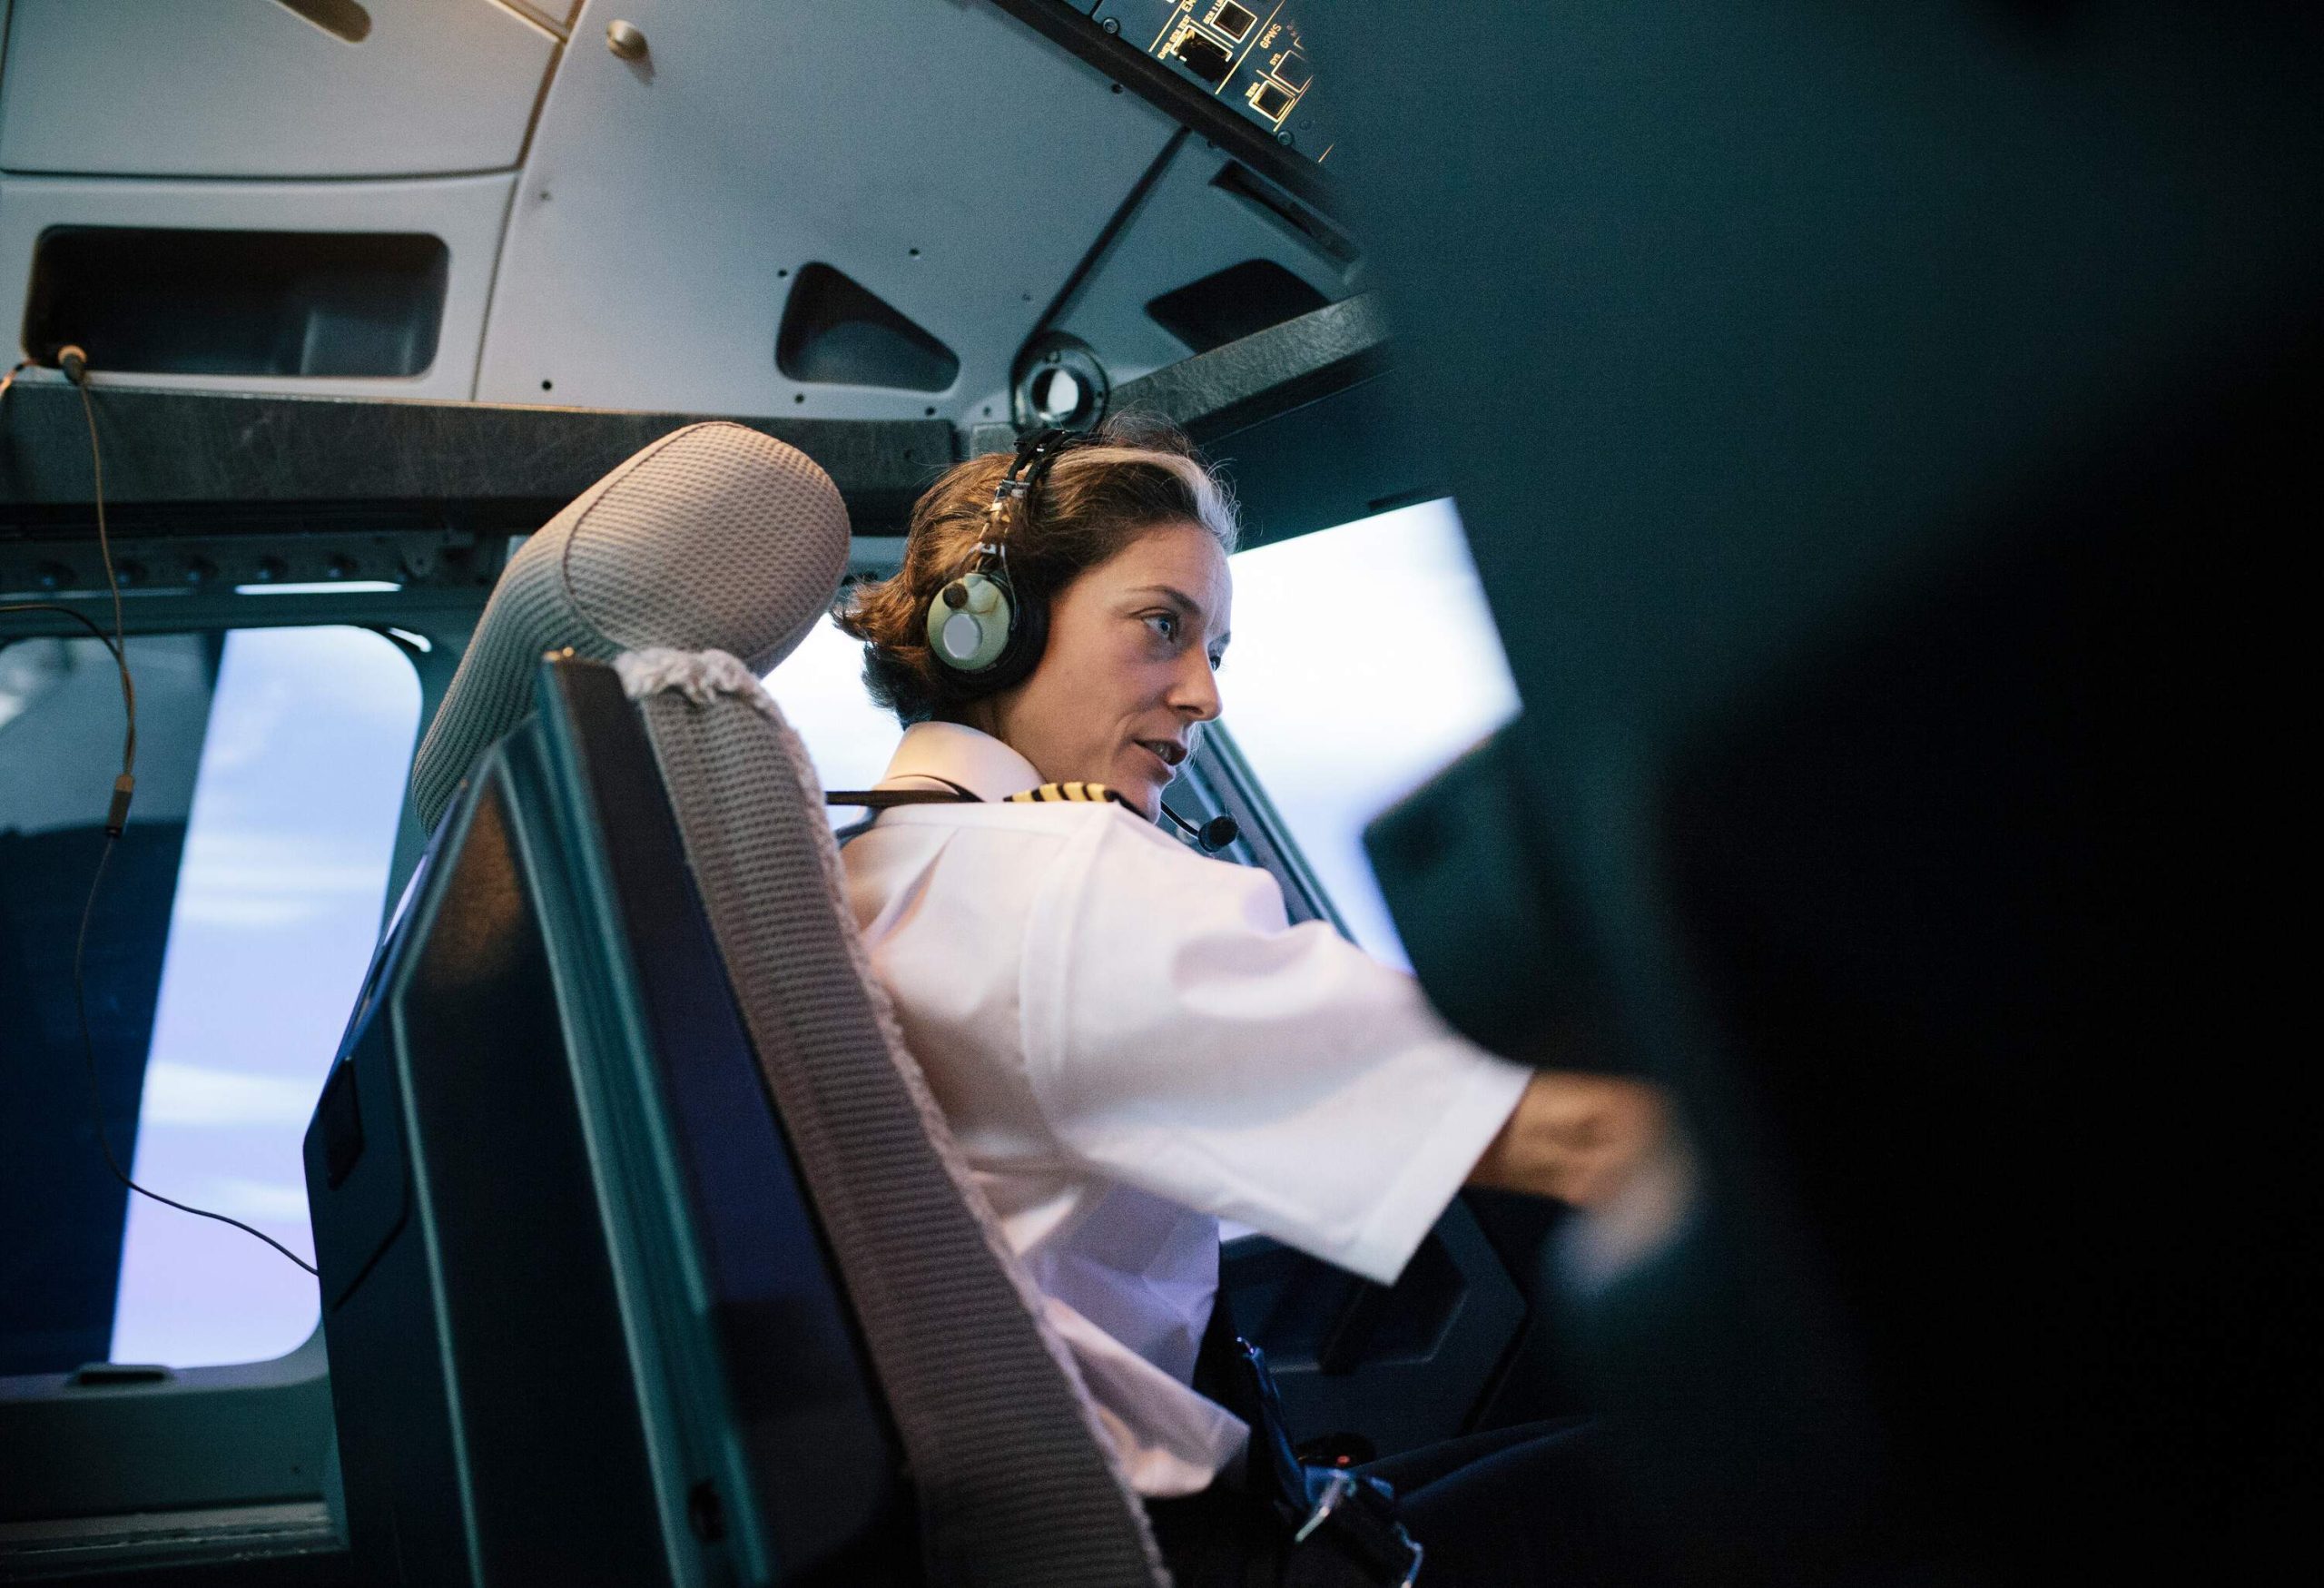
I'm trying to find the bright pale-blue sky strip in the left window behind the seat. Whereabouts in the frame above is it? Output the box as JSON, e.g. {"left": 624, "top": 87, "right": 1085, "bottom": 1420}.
{"left": 112, "top": 627, "right": 420, "bottom": 1367}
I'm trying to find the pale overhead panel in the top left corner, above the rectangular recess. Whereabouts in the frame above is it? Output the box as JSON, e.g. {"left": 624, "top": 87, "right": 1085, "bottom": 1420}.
{"left": 0, "top": 0, "right": 557, "bottom": 177}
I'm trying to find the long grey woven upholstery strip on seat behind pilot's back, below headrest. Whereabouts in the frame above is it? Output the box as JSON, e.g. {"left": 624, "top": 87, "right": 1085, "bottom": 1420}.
{"left": 639, "top": 693, "right": 1169, "bottom": 1588}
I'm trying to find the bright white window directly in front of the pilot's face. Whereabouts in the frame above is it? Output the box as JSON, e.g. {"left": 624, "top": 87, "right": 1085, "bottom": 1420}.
{"left": 1220, "top": 500, "right": 1518, "bottom": 965}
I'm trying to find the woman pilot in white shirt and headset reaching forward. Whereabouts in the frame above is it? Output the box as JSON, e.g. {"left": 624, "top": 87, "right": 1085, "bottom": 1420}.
{"left": 837, "top": 420, "right": 1659, "bottom": 1583}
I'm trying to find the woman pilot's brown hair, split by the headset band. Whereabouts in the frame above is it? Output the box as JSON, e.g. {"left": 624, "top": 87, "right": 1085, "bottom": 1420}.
{"left": 832, "top": 414, "right": 1241, "bottom": 728}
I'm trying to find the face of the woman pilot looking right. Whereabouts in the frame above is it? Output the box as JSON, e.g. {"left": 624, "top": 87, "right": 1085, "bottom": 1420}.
{"left": 976, "top": 521, "right": 1234, "bottom": 816}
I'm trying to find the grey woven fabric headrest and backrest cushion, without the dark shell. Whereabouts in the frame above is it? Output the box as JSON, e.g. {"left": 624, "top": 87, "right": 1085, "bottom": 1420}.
{"left": 416, "top": 426, "right": 1167, "bottom": 1588}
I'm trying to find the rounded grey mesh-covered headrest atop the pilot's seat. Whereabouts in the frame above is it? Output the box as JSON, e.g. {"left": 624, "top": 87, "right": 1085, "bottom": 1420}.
{"left": 411, "top": 423, "right": 848, "bottom": 828}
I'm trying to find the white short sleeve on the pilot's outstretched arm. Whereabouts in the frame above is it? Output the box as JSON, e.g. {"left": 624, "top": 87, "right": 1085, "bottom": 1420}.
{"left": 1020, "top": 812, "right": 1531, "bottom": 1284}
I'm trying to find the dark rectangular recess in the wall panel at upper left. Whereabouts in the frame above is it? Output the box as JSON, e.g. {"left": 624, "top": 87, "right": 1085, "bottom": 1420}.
{"left": 24, "top": 225, "right": 451, "bottom": 377}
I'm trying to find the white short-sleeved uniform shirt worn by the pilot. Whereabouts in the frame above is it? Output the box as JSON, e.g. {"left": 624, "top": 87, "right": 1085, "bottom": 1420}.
{"left": 843, "top": 723, "right": 1531, "bottom": 1495}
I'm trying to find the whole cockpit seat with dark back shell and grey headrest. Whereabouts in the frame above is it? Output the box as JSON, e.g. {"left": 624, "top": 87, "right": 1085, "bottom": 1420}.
{"left": 307, "top": 423, "right": 1167, "bottom": 1585}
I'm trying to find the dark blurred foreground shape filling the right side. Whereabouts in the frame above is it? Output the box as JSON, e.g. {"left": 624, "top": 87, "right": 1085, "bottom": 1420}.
{"left": 1320, "top": 0, "right": 2324, "bottom": 1583}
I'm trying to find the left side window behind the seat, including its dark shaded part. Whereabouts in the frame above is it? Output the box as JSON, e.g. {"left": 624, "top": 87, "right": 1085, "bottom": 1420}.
{"left": 0, "top": 627, "right": 420, "bottom": 1372}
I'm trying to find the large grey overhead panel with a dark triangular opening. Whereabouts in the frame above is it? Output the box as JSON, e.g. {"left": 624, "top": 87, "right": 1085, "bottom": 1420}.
{"left": 478, "top": 0, "right": 1189, "bottom": 423}
